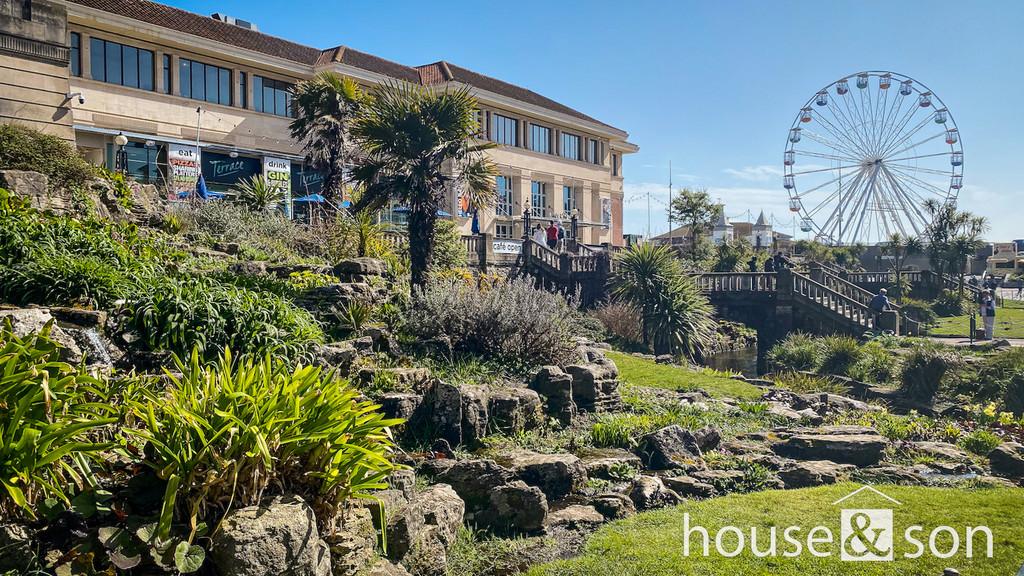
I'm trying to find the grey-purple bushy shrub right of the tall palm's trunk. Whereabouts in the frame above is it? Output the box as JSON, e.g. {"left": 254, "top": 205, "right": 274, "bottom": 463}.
{"left": 406, "top": 279, "right": 580, "bottom": 367}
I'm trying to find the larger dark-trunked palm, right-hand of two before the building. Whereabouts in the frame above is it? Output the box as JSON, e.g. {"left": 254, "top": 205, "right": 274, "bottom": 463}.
{"left": 352, "top": 83, "right": 497, "bottom": 288}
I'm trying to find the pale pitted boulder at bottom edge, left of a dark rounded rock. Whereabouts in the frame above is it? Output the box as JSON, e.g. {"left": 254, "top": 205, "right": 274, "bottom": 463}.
{"left": 385, "top": 484, "right": 466, "bottom": 576}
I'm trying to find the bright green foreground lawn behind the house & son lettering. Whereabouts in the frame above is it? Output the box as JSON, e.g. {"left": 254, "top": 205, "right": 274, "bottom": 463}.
{"left": 527, "top": 484, "right": 1024, "bottom": 576}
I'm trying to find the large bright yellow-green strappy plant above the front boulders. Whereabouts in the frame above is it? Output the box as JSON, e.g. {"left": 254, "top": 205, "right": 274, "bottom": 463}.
{"left": 129, "top": 344, "right": 400, "bottom": 533}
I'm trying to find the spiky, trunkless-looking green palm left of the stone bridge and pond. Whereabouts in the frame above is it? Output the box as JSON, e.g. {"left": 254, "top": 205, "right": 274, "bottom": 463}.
{"left": 610, "top": 244, "right": 715, "bottom": 358}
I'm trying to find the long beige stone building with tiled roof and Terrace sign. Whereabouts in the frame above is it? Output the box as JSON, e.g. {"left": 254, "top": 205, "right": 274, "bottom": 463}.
{"left": 0, "top": 0, "right": 638, "bottom": 246}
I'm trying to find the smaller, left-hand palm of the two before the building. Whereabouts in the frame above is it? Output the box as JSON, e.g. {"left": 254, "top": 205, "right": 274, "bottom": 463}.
{"left": 289, "top": 72, "right": 366, "bottom": 206}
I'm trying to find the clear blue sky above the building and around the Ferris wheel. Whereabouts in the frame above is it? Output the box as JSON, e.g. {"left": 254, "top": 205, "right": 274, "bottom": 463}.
{"left": 178, "top": 0, "right": 1024, "bottom": 240}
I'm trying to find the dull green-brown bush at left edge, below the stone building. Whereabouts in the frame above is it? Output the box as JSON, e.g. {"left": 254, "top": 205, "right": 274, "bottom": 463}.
{"left": 0, "top": 124, "right": 95, "bottom": 190}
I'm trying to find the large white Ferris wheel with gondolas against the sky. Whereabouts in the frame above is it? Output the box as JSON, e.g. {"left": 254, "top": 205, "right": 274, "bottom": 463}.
{"left": 782, "top": 72, "right": 964, "bottom": 244}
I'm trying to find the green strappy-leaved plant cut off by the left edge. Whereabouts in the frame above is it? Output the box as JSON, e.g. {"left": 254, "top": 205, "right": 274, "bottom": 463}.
{"left": 0, "top": 321, "right": 117, "bottom": 519}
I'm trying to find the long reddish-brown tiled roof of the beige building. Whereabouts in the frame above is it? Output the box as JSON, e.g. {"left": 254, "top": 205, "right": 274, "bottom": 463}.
{"left": 69, "top": 0, "right": 621, "bottom": 131}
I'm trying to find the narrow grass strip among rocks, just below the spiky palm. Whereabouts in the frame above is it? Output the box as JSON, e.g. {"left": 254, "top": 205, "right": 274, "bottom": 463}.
{"left": 608, "top": 352, "right": 762, "bottom": 400}
